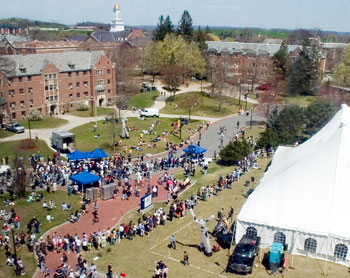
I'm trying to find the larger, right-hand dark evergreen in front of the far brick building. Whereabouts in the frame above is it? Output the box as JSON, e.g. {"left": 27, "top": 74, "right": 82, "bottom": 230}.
{"left": 288, "top": 45, "right": 321, "bottom": 96}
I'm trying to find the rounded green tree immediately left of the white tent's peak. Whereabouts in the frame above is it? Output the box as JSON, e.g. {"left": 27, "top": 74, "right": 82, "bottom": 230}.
{"left": 305, "top": 101, "right": 337, "bottom": 136}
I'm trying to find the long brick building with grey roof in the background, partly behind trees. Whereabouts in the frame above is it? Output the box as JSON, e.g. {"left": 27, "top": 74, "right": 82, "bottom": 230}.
{"left": 207, "top": 39, "right": 347, "bottom": 84}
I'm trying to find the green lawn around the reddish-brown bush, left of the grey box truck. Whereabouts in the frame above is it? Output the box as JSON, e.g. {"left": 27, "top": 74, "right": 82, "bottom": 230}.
{"left": 0, "top": 140, "right": 54, "bottom": 167}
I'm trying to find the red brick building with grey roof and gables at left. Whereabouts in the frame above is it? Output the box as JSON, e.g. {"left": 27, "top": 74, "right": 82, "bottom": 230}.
{"left": 0, "top": 51, "right": 116, "bottom": 119}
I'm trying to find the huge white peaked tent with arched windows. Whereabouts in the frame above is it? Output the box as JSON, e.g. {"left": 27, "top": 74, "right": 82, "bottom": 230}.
{"left": 236, "top": 105, "right": 350, "bottom": 266}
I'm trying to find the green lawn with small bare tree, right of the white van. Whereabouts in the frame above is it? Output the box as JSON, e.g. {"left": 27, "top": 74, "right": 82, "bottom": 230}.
{"left": 160, "top": 92, "right": 252, "bottom": 117}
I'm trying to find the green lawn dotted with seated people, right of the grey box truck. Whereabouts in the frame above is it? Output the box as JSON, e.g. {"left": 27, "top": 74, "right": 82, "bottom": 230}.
{"left": 70, "top": 118, "right": 199, "bottom": 157}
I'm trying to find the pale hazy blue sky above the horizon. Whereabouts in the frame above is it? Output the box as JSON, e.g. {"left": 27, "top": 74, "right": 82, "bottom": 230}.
{"left": 0, "top": 0, "right": 350, "bottom": 31}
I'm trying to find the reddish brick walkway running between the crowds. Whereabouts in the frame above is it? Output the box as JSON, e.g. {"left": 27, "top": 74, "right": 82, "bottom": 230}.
{"left": 33, "top": 169, "right": 179, "bottom": 278}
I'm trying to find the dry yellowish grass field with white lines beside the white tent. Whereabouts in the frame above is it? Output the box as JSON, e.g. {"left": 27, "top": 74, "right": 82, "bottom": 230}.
{"left": 84, "top": 156, "right": 347, "bottom": 278}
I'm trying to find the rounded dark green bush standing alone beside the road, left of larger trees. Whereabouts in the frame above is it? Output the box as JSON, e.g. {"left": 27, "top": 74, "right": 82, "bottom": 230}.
{"left": 219, "top": 140, "right": 250, "bottom": 165}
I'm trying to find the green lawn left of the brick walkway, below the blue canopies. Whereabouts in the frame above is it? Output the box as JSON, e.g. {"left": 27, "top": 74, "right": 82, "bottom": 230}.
{"left": 0, "top": 191, "right": 81, "bottom": 278}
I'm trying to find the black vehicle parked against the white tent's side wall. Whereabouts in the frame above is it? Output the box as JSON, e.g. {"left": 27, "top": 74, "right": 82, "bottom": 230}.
{"left": 226, "top": 235, "right": 261, "bottom": 273}
